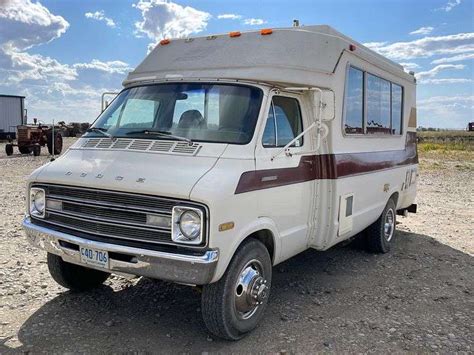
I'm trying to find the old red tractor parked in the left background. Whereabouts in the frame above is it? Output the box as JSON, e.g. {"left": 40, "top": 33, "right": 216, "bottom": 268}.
{"left": 5, "top": 119, "right": 63, "bottom": 156}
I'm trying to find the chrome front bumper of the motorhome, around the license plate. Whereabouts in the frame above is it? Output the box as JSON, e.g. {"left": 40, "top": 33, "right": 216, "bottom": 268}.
{"left": 23, "top": 217, "right": 219, "bottom": 285}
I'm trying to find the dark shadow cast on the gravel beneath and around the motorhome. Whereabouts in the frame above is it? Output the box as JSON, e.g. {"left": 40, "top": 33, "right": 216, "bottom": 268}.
{"left": 0, "top": 232, "right": 474, "bottom": 353}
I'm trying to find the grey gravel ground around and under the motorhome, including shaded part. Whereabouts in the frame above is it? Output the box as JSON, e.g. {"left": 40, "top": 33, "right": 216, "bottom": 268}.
{"left": 0, "top": 140, "right": 474, "bottom": 354}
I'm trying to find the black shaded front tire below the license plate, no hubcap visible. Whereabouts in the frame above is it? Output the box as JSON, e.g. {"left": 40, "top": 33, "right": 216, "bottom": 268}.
{"left": 48, "top": 253, "right": 110, "bottom": 291}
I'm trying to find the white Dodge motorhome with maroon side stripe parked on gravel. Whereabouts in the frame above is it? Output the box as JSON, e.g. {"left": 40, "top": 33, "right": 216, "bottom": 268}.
{"left": 23, "top": 26, "right": 418, "bottom": 339}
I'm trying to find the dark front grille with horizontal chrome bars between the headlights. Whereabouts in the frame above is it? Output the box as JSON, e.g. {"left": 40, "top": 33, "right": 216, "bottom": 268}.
{"left": 34, "top": 184, "right": 206, "bottom": 248}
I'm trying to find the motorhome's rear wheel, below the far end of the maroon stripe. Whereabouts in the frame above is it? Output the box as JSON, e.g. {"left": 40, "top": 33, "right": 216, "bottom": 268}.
{"left": 366, "top": 199, "right": 397, "bottom": 254}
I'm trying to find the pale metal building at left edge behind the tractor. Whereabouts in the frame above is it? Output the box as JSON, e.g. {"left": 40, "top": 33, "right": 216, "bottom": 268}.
{"left": 0, "top": 94, "right": 26, "bottom": 139}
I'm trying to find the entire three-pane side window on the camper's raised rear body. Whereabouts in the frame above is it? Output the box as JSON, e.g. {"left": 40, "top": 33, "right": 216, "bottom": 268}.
{"left": 344, "top": 67, "right": 403, "bottom": 135}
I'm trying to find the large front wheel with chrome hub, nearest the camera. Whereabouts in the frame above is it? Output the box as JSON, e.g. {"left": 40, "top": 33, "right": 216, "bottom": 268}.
{"left": 201, "top": 238, "right": 272, "bottom": 340}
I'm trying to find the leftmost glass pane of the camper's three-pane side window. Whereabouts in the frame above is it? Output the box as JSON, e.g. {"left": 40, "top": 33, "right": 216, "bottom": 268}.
{"left": 344, "top": 67, "right": 364, "bottom": 134}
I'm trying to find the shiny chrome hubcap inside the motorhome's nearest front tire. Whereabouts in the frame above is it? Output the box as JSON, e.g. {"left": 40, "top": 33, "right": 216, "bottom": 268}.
{"left": 234, "top": 259, "right": 268, "bottom": 319}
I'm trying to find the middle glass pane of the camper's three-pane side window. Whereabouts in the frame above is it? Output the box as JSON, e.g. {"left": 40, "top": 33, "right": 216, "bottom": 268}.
{"left": 367, "top": 74, "right": 391, "bottom": 134}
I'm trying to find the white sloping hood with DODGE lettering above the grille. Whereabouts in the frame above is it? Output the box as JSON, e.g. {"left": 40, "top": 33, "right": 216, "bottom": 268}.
{"left": 34, "top": 144, "right": 226, "bottom": 199}
